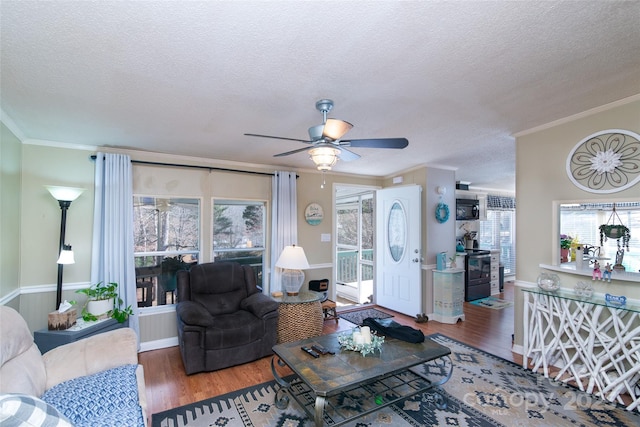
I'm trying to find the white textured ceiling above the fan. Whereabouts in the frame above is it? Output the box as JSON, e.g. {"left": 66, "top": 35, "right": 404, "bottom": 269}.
{"left": 0, "top": 0, "right": 640, "bottom": 190}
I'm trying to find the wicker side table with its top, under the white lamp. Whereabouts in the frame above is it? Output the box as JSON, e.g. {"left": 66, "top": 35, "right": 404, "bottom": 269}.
{"left": 275, "top": 291, "right": 324, "bottom": 343}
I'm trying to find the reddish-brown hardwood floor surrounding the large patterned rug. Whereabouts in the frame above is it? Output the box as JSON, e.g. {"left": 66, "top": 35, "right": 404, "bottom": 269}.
{"left": 139, "top": 282, "right": 522, "bottom": 417}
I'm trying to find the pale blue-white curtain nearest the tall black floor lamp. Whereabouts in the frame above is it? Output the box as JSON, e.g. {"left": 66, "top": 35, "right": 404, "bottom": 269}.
{"left": 91, "top": 153, "right": 140, "bottom": 337}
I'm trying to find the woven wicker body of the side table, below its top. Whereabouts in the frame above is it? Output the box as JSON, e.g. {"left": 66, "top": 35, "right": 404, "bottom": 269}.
{"left": 278, "top": 301, "right": 324, "bottom": 343}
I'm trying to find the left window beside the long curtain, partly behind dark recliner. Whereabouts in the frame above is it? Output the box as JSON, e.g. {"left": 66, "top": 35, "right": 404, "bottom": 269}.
{"left": 133, "top": 196, "right": 200, "bottom": 307}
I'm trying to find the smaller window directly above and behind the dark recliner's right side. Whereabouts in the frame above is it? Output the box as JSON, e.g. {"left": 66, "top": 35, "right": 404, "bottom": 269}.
{"left": 213, "top": 200, "right": 266, "bottom": 289}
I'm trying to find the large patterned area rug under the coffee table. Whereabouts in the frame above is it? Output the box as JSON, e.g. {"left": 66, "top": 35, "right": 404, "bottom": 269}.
{"left": 151, "top": 334, "right": 640, "bottom": 427}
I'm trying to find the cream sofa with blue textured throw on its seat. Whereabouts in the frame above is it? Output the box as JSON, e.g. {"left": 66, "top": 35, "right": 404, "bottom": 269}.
{"left": 0, "top": 306, "right": 147, "bottom": 427}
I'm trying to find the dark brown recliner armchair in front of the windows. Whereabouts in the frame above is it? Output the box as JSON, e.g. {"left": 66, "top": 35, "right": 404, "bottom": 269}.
{"left": 176, "top": 262, "right": 278, "bottom": 375}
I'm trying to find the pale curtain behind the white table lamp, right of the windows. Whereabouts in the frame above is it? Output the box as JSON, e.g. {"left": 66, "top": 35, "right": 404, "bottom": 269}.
{"left": 266, "top": 171, "right": 298, "bottom": 292}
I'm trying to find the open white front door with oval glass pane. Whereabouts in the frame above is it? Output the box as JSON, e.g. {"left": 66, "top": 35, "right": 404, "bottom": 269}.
{"left": 375, "top": 185, "right": 422, "bottom": 316}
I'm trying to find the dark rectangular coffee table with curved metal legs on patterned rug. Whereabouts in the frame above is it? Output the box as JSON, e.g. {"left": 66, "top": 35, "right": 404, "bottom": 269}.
{"left": 271, "top": 332, "right": 453, "bottom": 427}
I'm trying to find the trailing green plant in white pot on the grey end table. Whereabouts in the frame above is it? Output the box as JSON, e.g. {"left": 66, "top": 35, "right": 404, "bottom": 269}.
{"left": 76, "top": 282, "right": 133, "bottom": 323}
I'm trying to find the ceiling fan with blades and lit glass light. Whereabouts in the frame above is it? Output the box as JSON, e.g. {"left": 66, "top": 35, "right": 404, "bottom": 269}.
{"left": 245, "top": 99, "right": 409, "bottom": 171}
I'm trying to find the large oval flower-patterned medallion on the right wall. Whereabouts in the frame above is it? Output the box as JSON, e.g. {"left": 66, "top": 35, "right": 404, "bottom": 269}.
{"left": 567, "top": 129, "right": 640, "bottom": 193}
